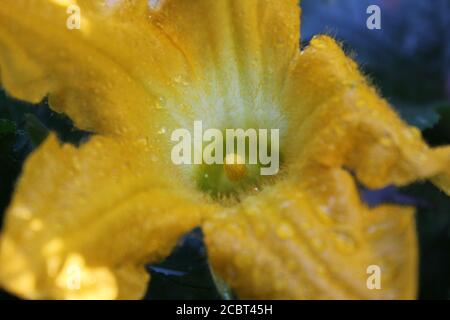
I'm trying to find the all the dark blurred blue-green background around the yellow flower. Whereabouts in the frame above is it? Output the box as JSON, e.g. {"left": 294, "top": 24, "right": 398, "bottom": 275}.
{"left": 0, "top": 0, "right": 450, "bottom": 299}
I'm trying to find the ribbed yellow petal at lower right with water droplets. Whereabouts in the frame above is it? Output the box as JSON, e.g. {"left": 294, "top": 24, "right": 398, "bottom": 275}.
{"left": 204, "top": 169, "right": 417, "bottom": 299}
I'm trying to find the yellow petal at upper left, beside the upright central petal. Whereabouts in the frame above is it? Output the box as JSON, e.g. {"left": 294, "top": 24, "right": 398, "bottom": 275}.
{"left": 0, "top": 0, "right": 192, "bottom": 135}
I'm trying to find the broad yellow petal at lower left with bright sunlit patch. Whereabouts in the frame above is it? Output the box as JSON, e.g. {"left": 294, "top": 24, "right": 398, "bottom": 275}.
{"left": 0, "top": 135, "right": 206, "bottom": 299}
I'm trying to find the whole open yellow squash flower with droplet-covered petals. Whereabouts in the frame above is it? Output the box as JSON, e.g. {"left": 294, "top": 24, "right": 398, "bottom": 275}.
{"left": 0, "top": 0, "right": 450, "bottom": 299}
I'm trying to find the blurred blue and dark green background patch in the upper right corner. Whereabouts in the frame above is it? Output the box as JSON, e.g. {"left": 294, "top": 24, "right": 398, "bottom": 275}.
{"left": 302, "top": 0, "right": 450, "bottom": 129}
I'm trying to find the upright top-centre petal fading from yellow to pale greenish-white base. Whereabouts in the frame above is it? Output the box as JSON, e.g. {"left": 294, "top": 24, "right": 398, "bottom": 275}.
{"left": 151, "top": 0, "right": 300, "bottom": 127}
